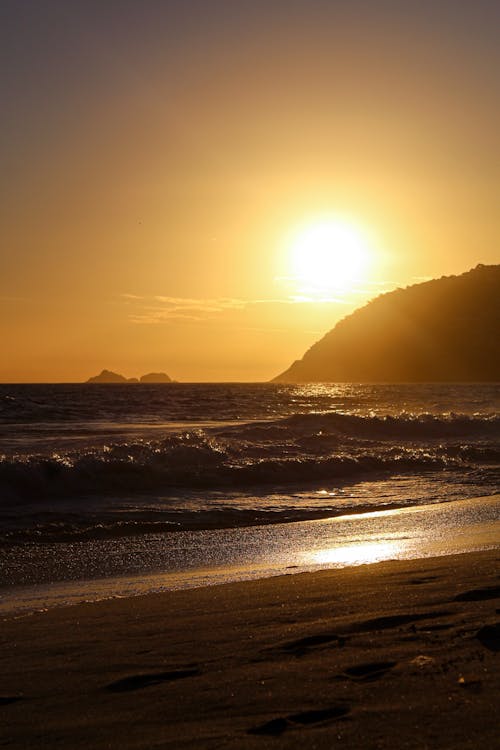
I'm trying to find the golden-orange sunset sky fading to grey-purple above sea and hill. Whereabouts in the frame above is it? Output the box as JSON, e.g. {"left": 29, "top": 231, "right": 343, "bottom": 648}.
{"left": 0, "top": 0, "right": 500, "bottom": 382}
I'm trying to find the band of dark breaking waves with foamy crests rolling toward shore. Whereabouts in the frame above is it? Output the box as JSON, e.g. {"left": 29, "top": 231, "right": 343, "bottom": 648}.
{"left": 0, "top": 414, "right": 500, "bottom": 505}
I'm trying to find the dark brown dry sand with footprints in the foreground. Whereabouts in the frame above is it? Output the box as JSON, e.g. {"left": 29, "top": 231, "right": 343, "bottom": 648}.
{"left": 0, "top": 550, "right": 500, "bottom": 750}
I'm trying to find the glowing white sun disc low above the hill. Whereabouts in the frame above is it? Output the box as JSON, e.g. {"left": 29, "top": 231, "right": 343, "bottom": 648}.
{"left": 290, "top": 219, "right": 370, "bottom": 295}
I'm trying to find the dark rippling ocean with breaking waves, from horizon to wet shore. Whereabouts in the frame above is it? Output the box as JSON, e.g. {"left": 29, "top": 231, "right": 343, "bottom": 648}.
{"left": 0, "top": 383, "right": 500, "bottom": 612}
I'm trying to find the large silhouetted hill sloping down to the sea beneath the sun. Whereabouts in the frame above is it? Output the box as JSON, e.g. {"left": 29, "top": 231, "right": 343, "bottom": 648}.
{"left": 274, "top": 265, "right": 500, "bottom": 383}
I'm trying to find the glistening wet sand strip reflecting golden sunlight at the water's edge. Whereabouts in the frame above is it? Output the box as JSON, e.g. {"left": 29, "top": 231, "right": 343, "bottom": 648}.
{"left": 0, "top": 494, "right": 500, "bottom": 618}
